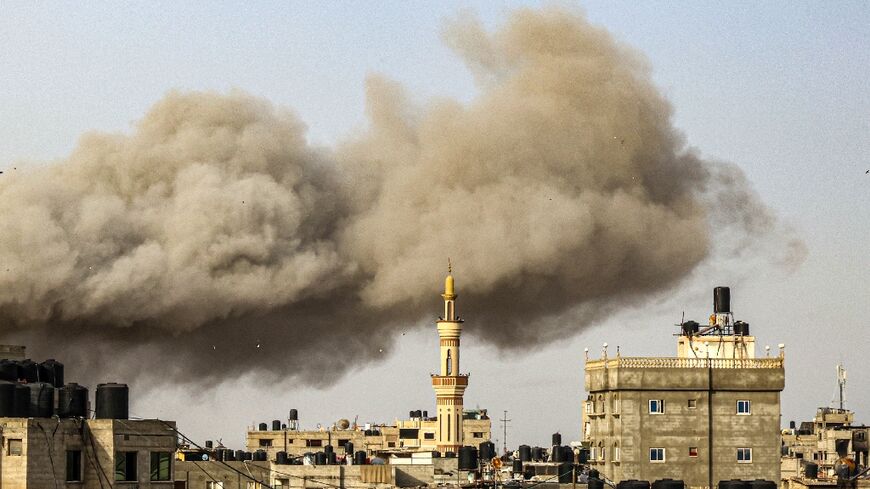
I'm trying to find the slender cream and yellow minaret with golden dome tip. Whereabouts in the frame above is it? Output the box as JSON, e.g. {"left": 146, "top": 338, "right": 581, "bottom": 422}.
{"left": 432, "top": 260, "right": 468, "bottom": 454}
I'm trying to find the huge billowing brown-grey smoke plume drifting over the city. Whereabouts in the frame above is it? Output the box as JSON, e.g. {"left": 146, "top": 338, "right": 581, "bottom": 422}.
{"left": 0, "top": 6, "right": 796, "bottom": 384}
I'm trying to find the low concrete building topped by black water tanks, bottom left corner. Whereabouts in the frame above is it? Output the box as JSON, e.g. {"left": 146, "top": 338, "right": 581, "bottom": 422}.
{"left": 0, "top": 417, "right": 176, "bottom": 489}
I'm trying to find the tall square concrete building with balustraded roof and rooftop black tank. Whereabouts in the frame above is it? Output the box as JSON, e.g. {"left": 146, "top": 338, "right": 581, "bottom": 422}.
{"left": 582, "top": 288, "right": 785, "bottom": 488}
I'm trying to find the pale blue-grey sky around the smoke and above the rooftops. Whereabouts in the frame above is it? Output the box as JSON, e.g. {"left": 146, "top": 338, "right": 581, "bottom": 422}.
{"left": 0, "top": 0, "right": 870, "bottom": 446}
